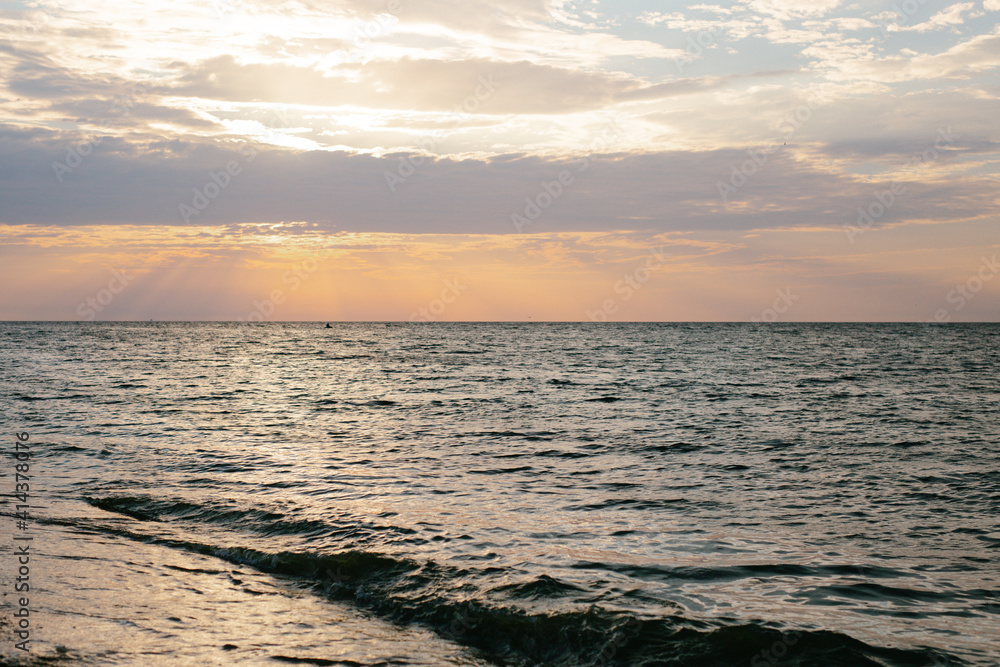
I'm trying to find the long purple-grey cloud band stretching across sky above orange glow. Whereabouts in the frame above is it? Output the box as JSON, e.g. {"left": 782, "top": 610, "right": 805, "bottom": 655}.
{"left": 0, "top": 122, "right": 1000, "bottom": 233}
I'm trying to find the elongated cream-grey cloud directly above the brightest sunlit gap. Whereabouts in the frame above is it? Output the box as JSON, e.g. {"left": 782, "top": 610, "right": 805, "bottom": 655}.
{"left": 164, "top": 56, "right": 721, "bottom": 114}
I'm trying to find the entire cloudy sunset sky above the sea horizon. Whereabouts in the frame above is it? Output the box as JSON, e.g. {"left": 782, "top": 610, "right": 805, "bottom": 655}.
{"left": 0, "top": 0, "right": 1000, "bottom": 322}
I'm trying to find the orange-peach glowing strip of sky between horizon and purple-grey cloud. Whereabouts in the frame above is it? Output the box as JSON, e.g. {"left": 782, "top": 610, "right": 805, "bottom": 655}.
{"left": 0, "top": 221, "right": 1000, "bottom": 321}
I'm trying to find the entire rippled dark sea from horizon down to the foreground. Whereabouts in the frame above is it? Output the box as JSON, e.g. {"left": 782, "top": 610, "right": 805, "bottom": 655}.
{"left": 0, "top": 323, "right": 1000, "bottom": 667}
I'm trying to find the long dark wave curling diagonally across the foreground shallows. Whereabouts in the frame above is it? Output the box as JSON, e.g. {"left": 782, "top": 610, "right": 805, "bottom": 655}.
{"left": 39, "top": 497, "right": 964, "bottom": 667}
